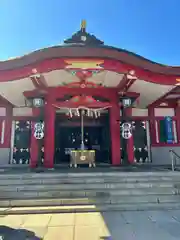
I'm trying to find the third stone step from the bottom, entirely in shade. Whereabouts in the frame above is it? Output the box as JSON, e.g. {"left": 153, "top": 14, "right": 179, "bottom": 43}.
{"left": 0, "top": 188, "right": 179, "bottom": 199}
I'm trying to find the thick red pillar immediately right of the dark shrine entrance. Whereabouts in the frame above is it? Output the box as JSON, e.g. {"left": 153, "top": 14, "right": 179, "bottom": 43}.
{"left": 110, "top": 104, "right": 121, "bottom": 165}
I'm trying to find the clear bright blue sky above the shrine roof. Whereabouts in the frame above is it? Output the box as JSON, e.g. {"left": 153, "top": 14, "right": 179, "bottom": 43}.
{"left": 0, "top": 0, "right": 180, "bottom": 66}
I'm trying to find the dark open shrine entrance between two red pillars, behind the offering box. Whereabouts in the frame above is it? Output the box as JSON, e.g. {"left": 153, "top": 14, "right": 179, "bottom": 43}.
{"left": 54, "top": 111, "right": 111, "bottom": 164}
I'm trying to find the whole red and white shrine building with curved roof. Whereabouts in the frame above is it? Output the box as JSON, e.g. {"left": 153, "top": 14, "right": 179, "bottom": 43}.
{"left": 0, "top": 21, "right": 180, "bottom": 168}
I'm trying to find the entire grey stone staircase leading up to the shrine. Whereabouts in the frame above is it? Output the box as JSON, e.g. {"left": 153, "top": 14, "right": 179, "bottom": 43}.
{"left": 0, "top": 172, "right": 180, "bottom": 214}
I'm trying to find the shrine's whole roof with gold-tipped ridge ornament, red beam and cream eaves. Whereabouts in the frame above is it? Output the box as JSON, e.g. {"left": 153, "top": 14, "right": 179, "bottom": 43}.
{"left": 0, "top": 21, "right": 180, "bottom": 108}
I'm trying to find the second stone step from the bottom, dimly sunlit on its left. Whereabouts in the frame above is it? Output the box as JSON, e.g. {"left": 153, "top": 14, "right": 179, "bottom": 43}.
{"left": 0, "top": 195, "right": 180, "bottom": 207}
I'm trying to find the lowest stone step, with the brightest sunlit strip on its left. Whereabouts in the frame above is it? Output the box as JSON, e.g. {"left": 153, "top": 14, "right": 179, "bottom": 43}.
{"left": 0, "top": 203, "right": 180, "bottom": 216}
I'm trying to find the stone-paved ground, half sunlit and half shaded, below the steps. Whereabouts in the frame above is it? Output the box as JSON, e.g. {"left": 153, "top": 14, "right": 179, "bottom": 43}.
{"left": 0, "top": 210, "right": 180, "bottom": 240}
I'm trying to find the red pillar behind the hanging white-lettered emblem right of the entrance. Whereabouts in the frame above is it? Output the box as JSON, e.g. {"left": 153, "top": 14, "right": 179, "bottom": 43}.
{"left": 125, "top": 108, "right": 134, "bottom": 163}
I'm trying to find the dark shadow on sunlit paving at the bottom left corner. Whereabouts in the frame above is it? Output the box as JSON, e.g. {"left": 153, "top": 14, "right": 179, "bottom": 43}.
{"left": 0, "top": 226, "right": 42, "bottom": 240}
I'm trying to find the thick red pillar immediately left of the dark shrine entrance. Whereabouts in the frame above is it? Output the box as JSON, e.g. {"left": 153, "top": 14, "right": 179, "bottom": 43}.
{"left": 44, "top": 98, "right": 55, "bottom": 168}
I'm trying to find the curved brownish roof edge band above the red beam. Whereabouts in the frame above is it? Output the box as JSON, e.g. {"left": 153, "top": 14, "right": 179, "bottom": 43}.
{"left": 0, "top": 44, "right": 180, "bottom": 75}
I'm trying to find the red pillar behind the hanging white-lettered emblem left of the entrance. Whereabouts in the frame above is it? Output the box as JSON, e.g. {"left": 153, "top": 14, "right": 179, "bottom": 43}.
{"left": 29, "top": 108, "right": 39, "bottom": 168}
